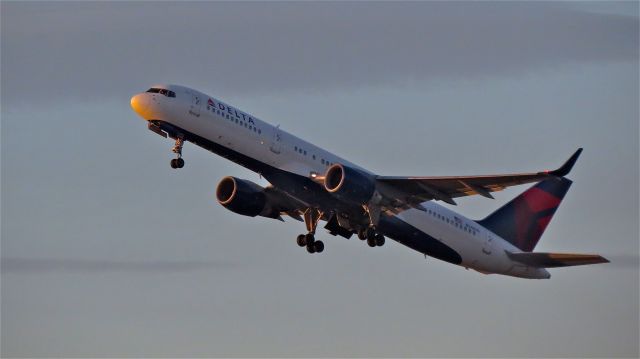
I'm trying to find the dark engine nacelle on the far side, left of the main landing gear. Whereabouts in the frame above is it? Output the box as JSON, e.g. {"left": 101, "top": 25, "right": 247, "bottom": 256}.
{"left": 216, "top": 176, "right": 280, "bottom": 218}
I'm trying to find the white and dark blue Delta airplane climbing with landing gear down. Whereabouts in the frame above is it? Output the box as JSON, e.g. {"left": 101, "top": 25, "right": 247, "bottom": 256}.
{"left": 131, "top": 85, "right": 609, "bottom": 279}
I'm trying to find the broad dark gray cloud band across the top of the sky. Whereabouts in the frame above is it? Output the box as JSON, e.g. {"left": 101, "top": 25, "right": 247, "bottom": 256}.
{"left": 2, "top": 2, "right": 638, "bottom": 105}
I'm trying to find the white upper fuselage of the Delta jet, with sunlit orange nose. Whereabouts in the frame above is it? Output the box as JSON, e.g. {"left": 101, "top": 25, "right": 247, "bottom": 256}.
{"left": 132, "top": 85, "right": 550, "bottom": 279}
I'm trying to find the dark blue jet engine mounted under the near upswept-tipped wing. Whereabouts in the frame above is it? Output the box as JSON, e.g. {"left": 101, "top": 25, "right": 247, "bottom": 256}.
{"left": 324, "top": 164, "right": 376, "bottom": 204}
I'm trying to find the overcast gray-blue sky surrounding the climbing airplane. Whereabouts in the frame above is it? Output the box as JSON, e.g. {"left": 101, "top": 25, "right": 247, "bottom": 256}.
{"left": 0, "top": 1, "right": 639, "bottom": 357}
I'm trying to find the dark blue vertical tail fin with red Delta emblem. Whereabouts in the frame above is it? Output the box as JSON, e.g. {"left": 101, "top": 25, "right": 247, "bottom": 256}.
{"left": 478, "top": 177, "right": 572, "bottom": 252}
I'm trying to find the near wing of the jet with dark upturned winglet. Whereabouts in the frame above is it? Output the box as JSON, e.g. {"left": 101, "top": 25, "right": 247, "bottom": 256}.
{"left": 376, "top": 148, "right": 582, "bottom": 213}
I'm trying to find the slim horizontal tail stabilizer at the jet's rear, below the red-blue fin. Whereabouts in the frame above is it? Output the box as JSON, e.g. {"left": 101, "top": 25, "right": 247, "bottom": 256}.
{"left": 507, "top": 252, "right": 609, "bottom": 268}
